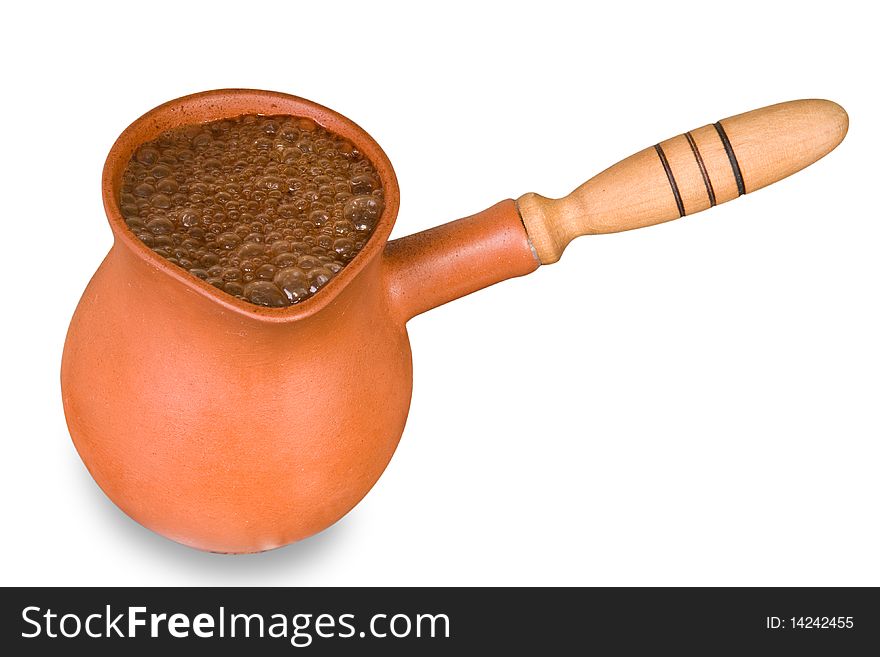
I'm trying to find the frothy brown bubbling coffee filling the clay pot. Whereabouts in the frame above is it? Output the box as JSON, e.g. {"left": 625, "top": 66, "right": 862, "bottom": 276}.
{"left": 119, "top": 115, "right": 384, "bottom": 307}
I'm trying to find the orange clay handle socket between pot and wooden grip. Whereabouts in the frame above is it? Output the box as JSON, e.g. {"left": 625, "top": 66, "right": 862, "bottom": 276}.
{"left": 384, "top": 200, "right": 541, "bottom": 321}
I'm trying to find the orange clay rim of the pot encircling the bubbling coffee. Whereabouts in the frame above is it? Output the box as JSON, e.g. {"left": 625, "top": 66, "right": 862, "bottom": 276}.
{"left": 101, "top": 89, "right": 400, "bottom": 322}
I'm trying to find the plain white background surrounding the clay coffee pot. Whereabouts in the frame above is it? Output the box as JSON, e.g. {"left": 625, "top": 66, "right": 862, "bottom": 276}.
{"left": 0, "top": 1, "right": 880, "bottom": 586}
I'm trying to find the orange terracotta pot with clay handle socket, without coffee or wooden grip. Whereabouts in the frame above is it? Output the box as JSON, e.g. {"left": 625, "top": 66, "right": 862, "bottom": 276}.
{"left": 61, "top": 90, "right": 538, "bottom": 552}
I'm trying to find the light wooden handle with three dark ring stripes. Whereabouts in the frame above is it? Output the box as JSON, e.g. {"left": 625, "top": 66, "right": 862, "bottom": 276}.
{"left": 517, "top": 100, "right": 849, "bottom": 264}
